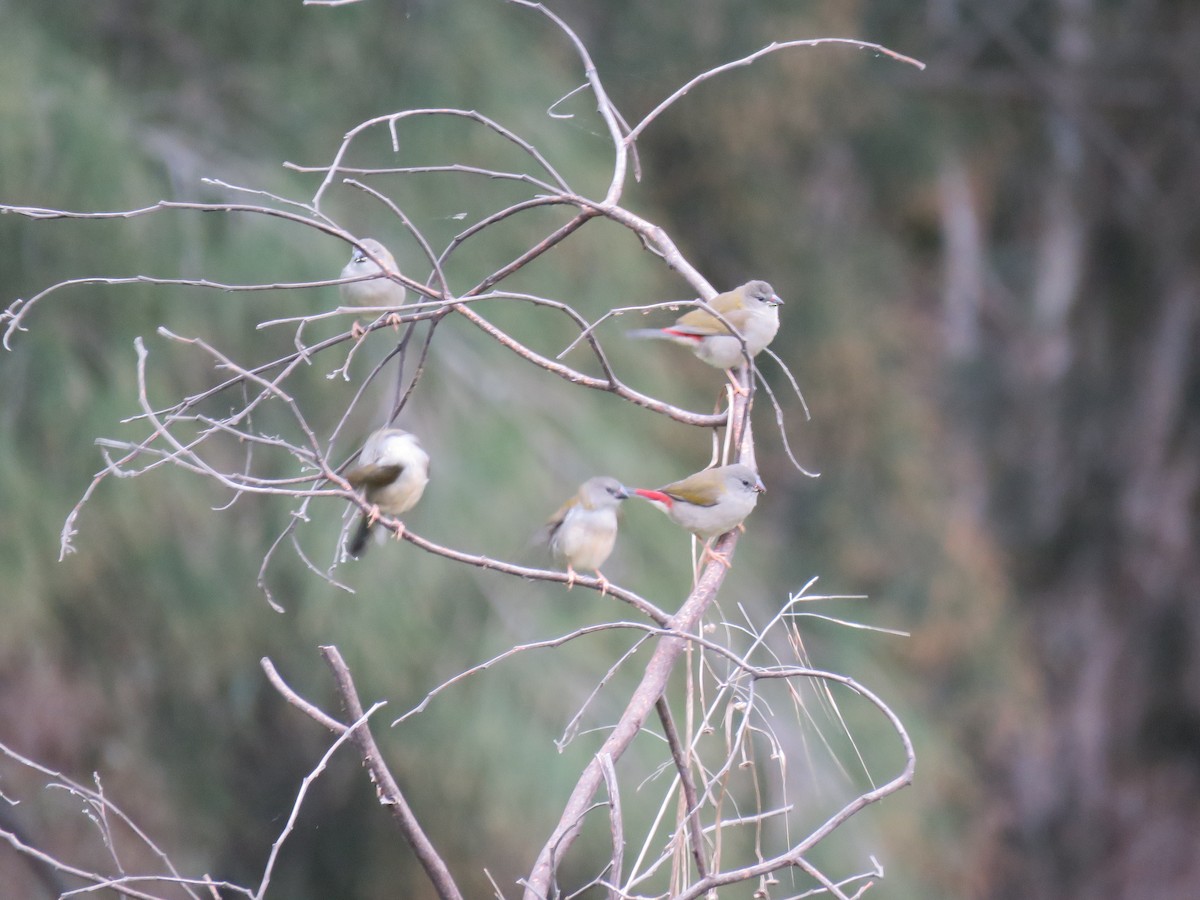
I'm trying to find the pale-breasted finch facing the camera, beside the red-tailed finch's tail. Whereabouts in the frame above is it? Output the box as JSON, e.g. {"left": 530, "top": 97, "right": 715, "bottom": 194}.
{"left": 541, "top": 476, "right": 629, "bottom": 593}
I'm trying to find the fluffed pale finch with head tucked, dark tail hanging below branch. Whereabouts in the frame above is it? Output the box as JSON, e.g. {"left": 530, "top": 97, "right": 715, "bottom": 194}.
{"left": 346, "top": 428, "right": 430, "bottom": 557}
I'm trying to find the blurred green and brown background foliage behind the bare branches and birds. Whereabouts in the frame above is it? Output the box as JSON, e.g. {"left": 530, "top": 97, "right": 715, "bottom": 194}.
{"left": 0, "top": 0, "right": 1200, "bottom": 900}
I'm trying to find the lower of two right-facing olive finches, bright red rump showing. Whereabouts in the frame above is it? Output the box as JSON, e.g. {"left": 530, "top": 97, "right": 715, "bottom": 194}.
{"left": 634, "top": 463, "right": 767, "bottom": 566}
